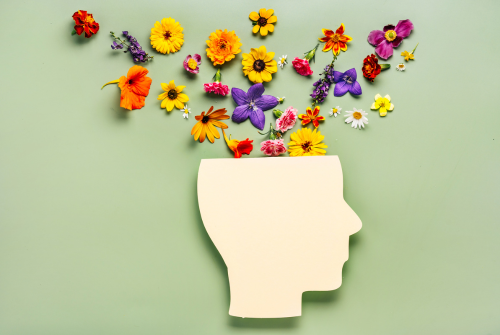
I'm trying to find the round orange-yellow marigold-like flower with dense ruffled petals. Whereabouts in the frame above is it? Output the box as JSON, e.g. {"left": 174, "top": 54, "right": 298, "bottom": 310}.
{"left": 207, "top": 29, "right": 242, "bottom": 66}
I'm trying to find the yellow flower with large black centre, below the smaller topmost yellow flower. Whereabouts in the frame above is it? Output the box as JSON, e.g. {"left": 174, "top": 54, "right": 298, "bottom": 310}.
{"left": 241, "top": 46, "right": 278, "bottom": 83}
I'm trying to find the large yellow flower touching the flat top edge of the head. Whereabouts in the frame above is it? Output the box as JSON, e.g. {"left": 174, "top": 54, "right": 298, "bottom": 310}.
{"left": 288, "top": 128, "right": 328, "bottom": 157}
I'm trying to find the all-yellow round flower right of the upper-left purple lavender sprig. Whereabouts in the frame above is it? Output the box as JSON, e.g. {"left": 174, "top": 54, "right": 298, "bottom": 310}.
{"left": 149, "top": 17, "right": 184, "bottom": 54}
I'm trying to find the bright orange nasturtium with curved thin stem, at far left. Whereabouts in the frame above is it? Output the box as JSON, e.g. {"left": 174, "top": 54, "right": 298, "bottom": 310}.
{"left": 101, "top": 65, "right": 152, "bottom": 110}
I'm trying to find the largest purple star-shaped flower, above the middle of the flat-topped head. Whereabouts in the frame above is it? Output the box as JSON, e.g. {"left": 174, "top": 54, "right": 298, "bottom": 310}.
{"left": 231, "top": 83, "right": 278, "bottom": 130}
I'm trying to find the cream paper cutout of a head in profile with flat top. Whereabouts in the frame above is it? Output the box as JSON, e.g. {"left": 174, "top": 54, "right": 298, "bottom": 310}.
{"left": 198, "top": 156, "right": 361, "bottom": 318}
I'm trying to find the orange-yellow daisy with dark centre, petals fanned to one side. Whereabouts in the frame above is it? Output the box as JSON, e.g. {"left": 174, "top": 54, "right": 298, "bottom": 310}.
{"left": 191, "top": 106, "right": 229, "bottom": 143}
